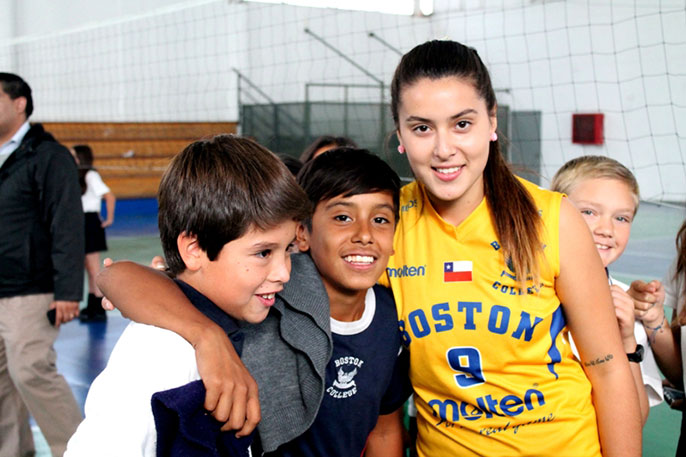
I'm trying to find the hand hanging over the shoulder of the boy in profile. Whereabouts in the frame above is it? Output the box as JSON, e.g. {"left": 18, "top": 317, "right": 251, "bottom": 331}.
{"left": 195, "top": 327, "right": 261, "bottom": 437}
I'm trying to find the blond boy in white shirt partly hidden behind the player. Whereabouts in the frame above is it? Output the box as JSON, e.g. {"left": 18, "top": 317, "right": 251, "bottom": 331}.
{"left": 550, "top": 155, "right": 662, "bottom": 424}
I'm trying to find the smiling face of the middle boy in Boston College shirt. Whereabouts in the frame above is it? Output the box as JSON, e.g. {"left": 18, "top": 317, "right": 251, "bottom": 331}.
{"left": 299, "top": 192, "right": 395, "bottom": 302}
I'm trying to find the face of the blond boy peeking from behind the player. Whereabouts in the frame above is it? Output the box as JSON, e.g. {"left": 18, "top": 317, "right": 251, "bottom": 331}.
{"left": 568, "top": 178, "right": 636, "bottom": 267}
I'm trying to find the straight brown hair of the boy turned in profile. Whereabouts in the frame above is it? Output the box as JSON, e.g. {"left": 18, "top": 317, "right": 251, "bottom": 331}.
{"left": 157, "top": 135, "right": 310, "bottom": 274}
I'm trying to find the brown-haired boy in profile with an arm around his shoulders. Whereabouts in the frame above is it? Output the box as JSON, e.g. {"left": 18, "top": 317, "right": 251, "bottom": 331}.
{"left": 65, "top": 135, "right": 310, "bottom": 457}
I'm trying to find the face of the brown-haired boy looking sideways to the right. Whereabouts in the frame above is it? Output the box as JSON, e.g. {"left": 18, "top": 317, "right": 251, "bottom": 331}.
{"left": 179, "top": 221, "right": 297, "bottom": 323}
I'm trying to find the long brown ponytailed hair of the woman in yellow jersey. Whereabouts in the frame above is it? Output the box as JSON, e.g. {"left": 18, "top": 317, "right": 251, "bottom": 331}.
{"left": 391, "top": 40, "right": 543, "bottom": 285}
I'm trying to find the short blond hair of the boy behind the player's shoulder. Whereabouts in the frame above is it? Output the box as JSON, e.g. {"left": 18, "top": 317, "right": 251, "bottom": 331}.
{"left": 550, "top": 155, "right": 641, "bottom": 210}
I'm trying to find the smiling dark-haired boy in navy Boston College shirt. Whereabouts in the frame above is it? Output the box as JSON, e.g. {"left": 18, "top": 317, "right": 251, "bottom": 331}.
{"left": 268, "top": 148, "right": 410, "bottom": 457}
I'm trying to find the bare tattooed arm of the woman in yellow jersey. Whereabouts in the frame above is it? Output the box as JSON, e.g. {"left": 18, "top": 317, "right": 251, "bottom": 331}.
{"left": 555, "top": 199, "right": 641, "bottom": 456}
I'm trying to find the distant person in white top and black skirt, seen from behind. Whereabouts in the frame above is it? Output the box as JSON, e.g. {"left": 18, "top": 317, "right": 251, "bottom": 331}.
{"left": 72, "top": 144, "right": 116, "bottom": 322}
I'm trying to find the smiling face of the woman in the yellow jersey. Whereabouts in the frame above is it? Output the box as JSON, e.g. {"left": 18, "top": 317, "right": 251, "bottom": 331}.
{"left": 398, "top": 76, "right": 497, "bottom": 224}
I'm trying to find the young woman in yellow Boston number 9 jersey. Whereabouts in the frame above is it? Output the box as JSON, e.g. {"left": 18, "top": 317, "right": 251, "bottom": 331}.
{"left": 387, "top": 41, "right": 641, "bottom": 457}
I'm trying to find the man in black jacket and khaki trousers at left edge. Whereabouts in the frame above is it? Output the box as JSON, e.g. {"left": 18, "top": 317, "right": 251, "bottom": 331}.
{"left": 0, "top": 73, "right": 84, "bottom": 457}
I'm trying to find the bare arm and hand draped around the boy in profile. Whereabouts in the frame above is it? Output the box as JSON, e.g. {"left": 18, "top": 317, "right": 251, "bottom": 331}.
{"left": 97, "top": 261, "right": 260, "bottom": 436}
